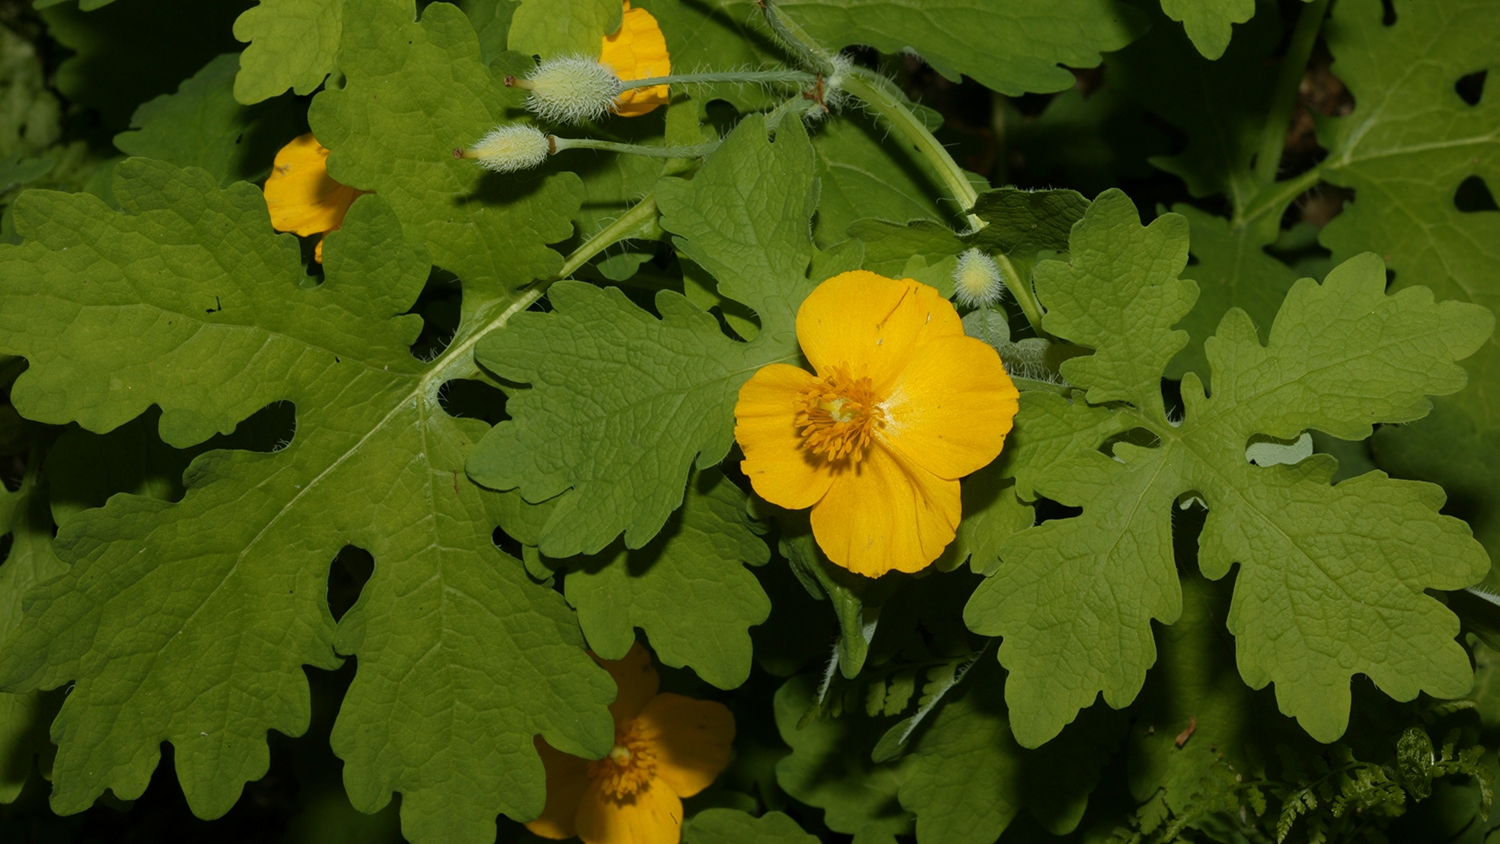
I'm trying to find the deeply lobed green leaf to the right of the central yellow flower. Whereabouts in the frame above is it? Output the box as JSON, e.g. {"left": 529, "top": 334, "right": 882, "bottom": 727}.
{"left": 965, "top": 190, "right": 1494, "bottom": 747}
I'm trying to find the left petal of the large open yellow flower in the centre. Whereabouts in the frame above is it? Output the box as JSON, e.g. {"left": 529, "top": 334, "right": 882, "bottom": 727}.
{"left": 735, "top": 363, "right": 834, "bottom": 510}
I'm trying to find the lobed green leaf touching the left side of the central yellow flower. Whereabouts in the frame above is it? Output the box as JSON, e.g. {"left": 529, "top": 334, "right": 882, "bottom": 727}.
{"left": 468, "top": 117, "right": 815, "bottom": 558}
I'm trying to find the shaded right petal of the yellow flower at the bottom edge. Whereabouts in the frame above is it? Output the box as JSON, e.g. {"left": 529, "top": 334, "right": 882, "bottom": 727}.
{"left": 636, "top": 694, "right": 735, "bottom": 798}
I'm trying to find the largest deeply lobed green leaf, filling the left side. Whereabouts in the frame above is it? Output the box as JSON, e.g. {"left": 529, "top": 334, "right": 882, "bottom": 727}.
{"left": 0, "top": 159, "right": 614, "bottom": 843}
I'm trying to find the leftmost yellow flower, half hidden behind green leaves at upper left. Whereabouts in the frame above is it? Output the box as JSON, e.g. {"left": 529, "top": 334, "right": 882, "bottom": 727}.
{"left": 264, "top": 132, "right": 368, "bottom": 264}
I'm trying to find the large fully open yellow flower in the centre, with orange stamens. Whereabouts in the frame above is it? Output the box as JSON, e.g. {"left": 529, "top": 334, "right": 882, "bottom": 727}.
{"left": 735, "top": 270, "right": 1019, "bottom": 577}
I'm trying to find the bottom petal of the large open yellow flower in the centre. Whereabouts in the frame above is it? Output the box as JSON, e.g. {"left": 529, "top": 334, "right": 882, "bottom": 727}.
{"left": 813, "top": 442, "right": 962, "bottom": 577}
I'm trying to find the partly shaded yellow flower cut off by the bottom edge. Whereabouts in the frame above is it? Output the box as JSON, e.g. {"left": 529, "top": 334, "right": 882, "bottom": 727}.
{"left": 527, "top": 643, "right": 735, "bottom": 844}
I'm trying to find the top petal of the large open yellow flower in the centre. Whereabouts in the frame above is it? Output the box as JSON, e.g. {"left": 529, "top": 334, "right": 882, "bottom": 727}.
{"left": 797, "top": 270, "right": 963, "bottom": 396}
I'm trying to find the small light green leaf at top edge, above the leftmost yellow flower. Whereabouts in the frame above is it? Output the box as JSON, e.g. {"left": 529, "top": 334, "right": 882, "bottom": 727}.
{"left": 234, "top": 0, "right": 344, "bottom": 105}
